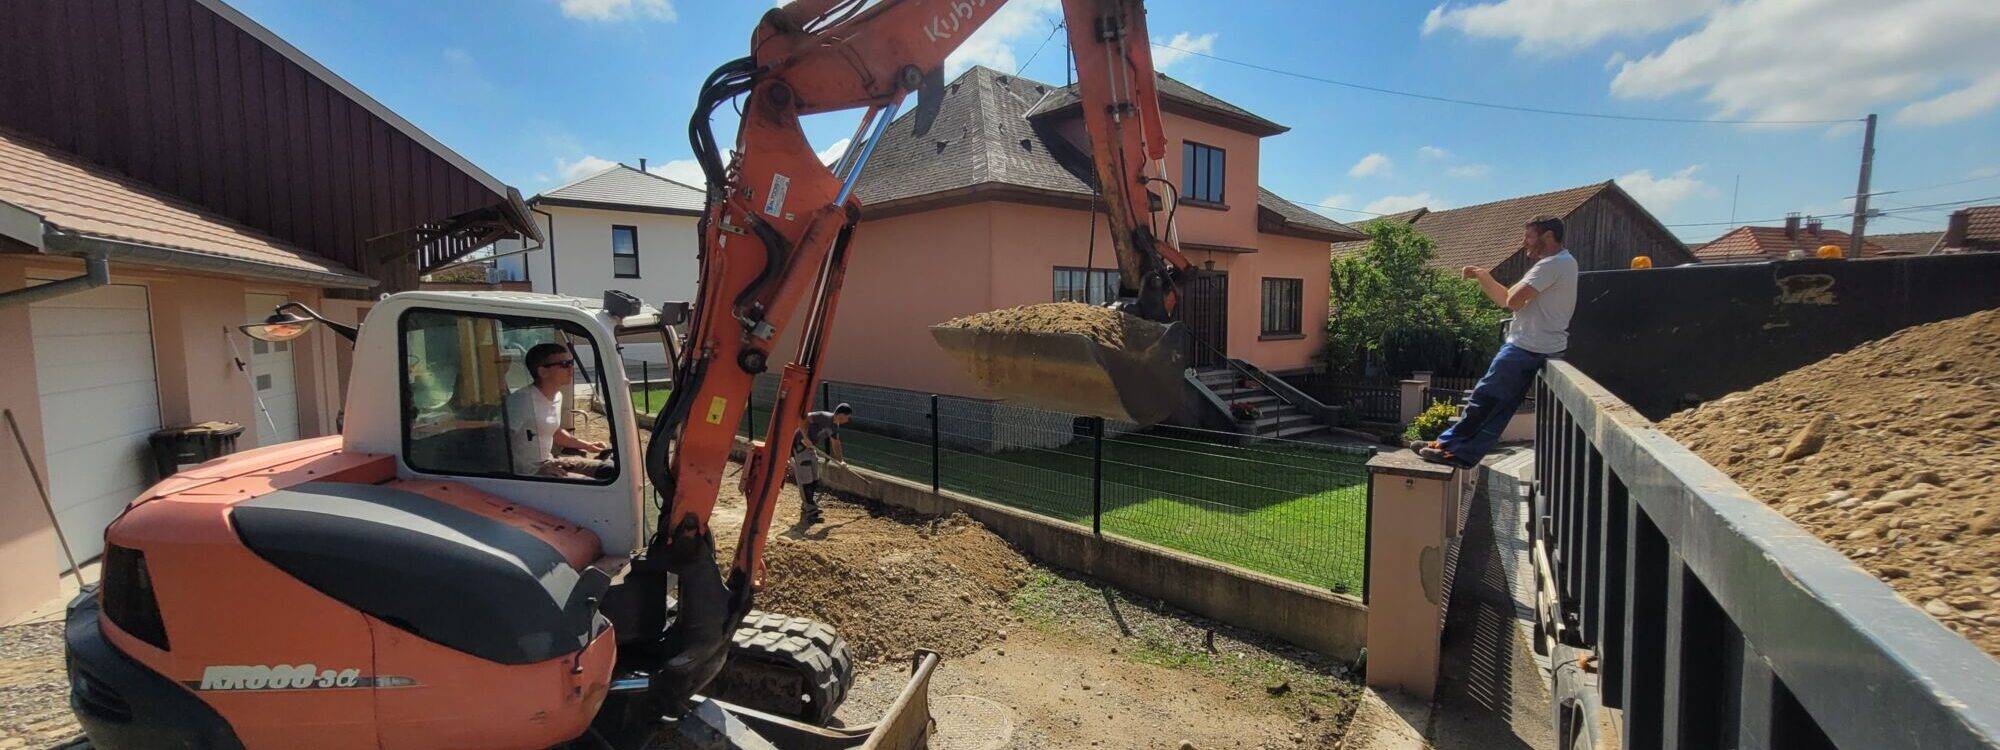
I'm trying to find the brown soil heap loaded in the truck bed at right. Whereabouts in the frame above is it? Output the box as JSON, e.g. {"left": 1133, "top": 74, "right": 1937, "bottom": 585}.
{"left": 1660, "top": 310, "right": 2000, "bottom": 656}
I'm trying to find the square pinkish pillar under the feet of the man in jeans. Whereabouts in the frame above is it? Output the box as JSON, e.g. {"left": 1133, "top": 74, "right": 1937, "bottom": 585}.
{"left": 1368, "top": 450, "right": 1458, "bottom": 700}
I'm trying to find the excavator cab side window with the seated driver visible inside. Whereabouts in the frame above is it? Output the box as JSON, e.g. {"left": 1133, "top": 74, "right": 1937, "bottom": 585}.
{"left": 400, "top": 310, "right": 618, "bottom": 484}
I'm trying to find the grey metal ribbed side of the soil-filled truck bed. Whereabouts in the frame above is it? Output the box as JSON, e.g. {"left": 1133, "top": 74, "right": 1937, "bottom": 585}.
{"left": 1532, "top": 360, "right": 2000, "bottom": 748}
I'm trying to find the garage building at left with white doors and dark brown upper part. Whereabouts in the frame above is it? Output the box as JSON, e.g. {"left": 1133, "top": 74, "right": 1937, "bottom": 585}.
{"left": 0, "top": 0, "right": 538, "bottom": 622}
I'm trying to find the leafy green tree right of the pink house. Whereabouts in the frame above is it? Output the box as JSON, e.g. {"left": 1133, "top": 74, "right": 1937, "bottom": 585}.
{"left": 1326, "top": 220, "right": 1506, "bottom": 378}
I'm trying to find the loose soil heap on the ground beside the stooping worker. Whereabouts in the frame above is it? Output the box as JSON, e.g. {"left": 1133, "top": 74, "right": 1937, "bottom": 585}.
{"left": 714, "top": 482, "right": 1028, "bottom": 662}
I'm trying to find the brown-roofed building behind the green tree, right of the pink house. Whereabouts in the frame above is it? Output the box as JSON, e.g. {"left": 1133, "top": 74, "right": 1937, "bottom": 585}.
{"left": 1334, "top": 180, "right": 1694, "bottom": 284}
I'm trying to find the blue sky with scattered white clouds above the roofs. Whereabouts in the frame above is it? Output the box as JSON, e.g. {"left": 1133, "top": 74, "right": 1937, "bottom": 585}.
{"left": 232, "top": 0, "right": 2000, "bottom": 242}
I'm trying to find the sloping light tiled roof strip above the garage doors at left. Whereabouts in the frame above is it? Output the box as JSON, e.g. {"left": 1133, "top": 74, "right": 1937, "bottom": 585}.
{"left": 0, "top": 130, "right": 374, "bottom": 288}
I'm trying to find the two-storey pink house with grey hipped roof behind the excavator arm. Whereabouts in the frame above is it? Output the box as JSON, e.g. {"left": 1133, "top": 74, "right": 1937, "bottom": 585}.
{"left": 796, "top": 68, "right": 1362, "bottom": 426}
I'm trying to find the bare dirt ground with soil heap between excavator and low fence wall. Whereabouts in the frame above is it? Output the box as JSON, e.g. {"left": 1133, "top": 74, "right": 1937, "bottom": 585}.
{"left": 716, "top": 478, "right": 1358, "bottom": 750}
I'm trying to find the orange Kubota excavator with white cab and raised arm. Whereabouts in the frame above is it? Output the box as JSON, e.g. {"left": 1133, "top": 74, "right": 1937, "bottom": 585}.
{"left": 66, "top": 0, "right": 1188, "bottom": 750}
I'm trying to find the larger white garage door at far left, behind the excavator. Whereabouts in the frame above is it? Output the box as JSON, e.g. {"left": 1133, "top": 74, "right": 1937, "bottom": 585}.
{"left": 28, "top": 284, "right": 160, "bottom": 560}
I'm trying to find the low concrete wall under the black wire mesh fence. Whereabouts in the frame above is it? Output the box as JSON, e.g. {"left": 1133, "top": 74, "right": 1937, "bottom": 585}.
{"left": 804, "top": 452, "right": 1368, "bottom": 662}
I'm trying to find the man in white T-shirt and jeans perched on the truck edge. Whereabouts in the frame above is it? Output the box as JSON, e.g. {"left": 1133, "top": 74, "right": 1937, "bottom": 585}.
{"left": 1410, "top": 216, "right": 1576, "bottom": 468}
